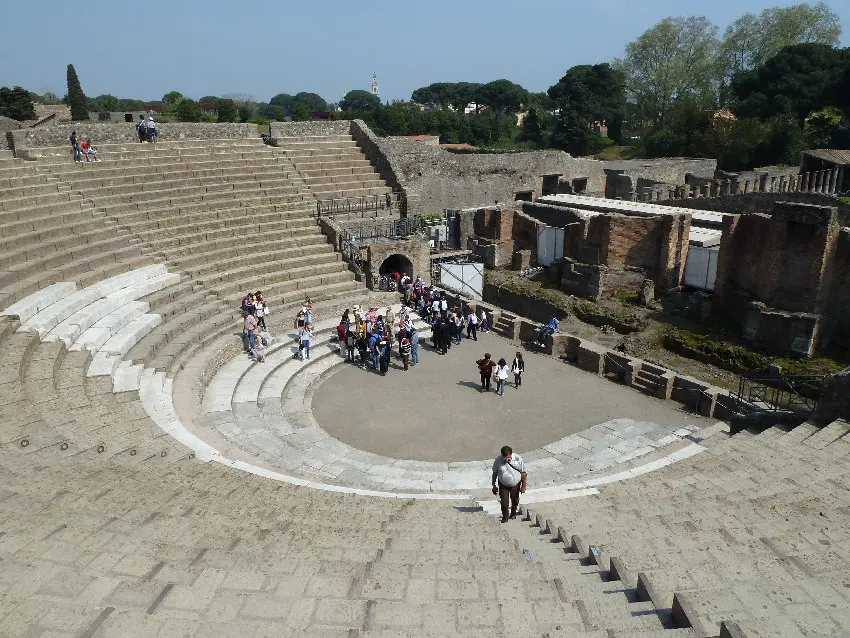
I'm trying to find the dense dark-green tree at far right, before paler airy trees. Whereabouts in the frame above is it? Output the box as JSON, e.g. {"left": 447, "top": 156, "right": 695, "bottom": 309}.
{"left": 731, "top": 44, "right": 850, "bottom": 125}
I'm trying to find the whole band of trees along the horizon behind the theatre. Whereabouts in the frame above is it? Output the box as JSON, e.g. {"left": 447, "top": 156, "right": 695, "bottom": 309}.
{"left": 0, "top": 2, "right": 850, "bottom": 170}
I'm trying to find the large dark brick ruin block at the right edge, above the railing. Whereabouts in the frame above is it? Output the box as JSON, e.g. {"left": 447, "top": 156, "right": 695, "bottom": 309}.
{"left": 713, "top": 202, "right": 850, "bottom": 356}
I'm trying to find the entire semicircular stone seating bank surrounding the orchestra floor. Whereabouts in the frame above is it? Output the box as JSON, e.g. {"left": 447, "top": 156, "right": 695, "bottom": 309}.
{"left": 0, "top": 136, "right": 850, "bottom": 637}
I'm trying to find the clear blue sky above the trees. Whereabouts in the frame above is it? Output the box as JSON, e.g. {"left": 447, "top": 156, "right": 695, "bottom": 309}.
{"left": 0, "top": 0, "right": 850, "bottom": 102}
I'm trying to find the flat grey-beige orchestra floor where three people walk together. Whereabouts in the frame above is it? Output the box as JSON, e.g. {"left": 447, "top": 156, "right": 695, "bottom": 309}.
{"left": 313, "top": 332, "right": 704, "bottom": 462}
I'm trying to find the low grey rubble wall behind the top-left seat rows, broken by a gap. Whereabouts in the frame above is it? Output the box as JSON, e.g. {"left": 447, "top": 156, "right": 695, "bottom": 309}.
{"left": 12, "top": 122, "right": 260, "bottom": 154}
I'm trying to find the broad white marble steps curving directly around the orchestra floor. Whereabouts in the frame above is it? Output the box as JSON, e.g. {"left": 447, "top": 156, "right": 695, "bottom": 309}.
{"left": 189, "top": 308, "right": 703, "bottom": 502}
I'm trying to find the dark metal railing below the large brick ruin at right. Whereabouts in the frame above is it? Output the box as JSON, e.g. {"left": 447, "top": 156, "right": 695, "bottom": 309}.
{"left": 737, "top": 375, "right": 826, "bottom": 412}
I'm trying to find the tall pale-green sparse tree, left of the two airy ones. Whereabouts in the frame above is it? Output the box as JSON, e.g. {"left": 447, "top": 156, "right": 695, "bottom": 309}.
{"left": 615, "top": 16, "right": 720, "bottom": 126}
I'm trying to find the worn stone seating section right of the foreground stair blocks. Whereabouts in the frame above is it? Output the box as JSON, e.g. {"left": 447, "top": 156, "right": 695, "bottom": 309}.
{"left": 532, "top": 421, "right": 850, "bottom": 638}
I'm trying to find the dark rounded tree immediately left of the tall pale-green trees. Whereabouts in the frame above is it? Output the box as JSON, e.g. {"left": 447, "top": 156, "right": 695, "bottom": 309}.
{"left": 548, "top": 64, "right": 626, "bottom": 155}
